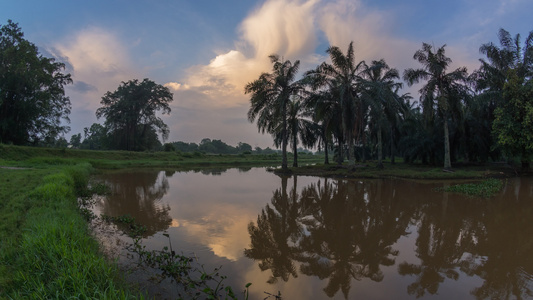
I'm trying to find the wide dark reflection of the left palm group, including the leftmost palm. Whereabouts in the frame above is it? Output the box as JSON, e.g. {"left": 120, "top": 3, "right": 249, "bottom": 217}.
{"left": 245, "top": 179, "right": 410, "bottom": 298}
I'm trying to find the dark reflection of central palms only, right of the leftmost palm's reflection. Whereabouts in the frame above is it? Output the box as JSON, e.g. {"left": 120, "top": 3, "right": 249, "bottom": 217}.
{"left": 301, "top": 181, "right": 409, "bottom": 298}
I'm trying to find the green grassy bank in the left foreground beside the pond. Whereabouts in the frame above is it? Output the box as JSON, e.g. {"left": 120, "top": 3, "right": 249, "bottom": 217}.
{"left": 0, "top": 163, "right": 138, "bottom": 299}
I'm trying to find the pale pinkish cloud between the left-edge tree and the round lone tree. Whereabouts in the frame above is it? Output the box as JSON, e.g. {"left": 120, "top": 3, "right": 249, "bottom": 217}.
{"left": 48, "top": 27, "right": 137, "bottom": 134}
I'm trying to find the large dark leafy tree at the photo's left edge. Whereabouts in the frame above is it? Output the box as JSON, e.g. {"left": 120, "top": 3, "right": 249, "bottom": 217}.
{"left": 0, "top": 20, "right": 72, "bottom": 145}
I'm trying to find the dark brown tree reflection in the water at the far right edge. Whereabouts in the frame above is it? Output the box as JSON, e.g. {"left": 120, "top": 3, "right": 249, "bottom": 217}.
{"left": 463, "top": 179, "right": 533, "bottom": 299}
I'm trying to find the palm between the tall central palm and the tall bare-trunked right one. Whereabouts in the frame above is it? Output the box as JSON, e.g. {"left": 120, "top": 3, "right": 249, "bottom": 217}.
{"left": 361, "top": 59, "right": 401, "bottom": 168}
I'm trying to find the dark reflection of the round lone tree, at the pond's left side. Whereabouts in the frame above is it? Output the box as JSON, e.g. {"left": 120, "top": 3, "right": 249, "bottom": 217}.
{"left": 102, "top": 172, "right": 172, "bottom": 237}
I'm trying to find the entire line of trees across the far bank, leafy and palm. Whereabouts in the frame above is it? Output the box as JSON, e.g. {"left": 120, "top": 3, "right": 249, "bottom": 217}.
{"left": 0, "top": 20, "right": 533, "bottom": 169}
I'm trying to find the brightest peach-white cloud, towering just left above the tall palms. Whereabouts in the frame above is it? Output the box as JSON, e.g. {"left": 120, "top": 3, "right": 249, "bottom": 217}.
{"left": 166, "top": 0, "right": 317, "bottom": 107}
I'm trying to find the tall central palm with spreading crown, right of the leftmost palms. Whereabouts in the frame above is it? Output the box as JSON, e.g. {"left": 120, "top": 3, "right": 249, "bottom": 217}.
{"left": 305, "top": 42, "right": 363, "bottom": 165}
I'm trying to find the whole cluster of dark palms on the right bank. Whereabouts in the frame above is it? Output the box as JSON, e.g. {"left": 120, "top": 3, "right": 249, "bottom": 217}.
{"left": 245, "top": 29, "right": 533, "bottom": 169}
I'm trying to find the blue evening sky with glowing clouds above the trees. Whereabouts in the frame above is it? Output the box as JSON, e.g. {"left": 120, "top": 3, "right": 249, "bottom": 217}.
{"left": 0, "top": 0, "right": 533, "bottom": 148}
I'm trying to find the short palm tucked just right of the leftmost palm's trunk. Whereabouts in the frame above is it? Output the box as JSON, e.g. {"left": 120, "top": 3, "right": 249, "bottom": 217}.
{"left": 274, "top": 99, "right": 318, "bottom": 167}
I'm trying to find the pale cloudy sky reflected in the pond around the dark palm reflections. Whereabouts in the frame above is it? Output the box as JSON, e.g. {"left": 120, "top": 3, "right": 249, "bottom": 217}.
{"left": 92, "top": 168, "right": 532, "bottom": 299}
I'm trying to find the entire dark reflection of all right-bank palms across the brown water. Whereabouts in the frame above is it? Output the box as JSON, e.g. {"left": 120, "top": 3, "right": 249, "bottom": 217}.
{"left": 244, "top": 177, "right": 533, "bottom": 299}
